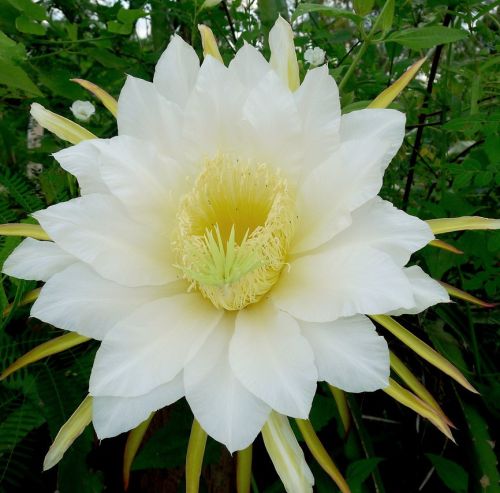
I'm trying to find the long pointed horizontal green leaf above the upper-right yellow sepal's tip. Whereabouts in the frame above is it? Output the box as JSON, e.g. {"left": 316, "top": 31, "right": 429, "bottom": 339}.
{"left": 385, "top": 26, "right": 468, "bottom": 50}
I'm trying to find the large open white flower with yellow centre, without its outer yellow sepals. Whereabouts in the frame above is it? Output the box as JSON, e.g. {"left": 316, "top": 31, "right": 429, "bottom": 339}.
{"left": 4, "top": 19, "right": 448, "bottom": 458}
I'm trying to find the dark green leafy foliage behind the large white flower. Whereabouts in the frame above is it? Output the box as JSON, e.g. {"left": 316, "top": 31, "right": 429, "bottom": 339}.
{"left": 0, "top": 0, "right": 500, "bottom": 493}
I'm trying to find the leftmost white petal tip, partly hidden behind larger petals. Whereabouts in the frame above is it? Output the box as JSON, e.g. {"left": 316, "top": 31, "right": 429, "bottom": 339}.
{"left": 2, "top": 238, "right": 77, "bottom": 281}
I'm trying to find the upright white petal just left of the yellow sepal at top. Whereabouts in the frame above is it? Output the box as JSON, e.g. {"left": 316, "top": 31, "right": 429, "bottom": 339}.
{"left": 153, "top": 35, "right": 200, "bottom": 106}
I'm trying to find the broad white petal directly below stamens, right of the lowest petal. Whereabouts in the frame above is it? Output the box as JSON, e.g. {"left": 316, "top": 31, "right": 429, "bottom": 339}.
{"left": 229, "top": 301, "right": 317, "bottom": 418}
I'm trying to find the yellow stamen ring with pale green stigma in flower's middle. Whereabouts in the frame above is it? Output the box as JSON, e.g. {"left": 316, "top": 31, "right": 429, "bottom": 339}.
{"left": 172, "top": 155, "right": 297, "bottom": 310}
